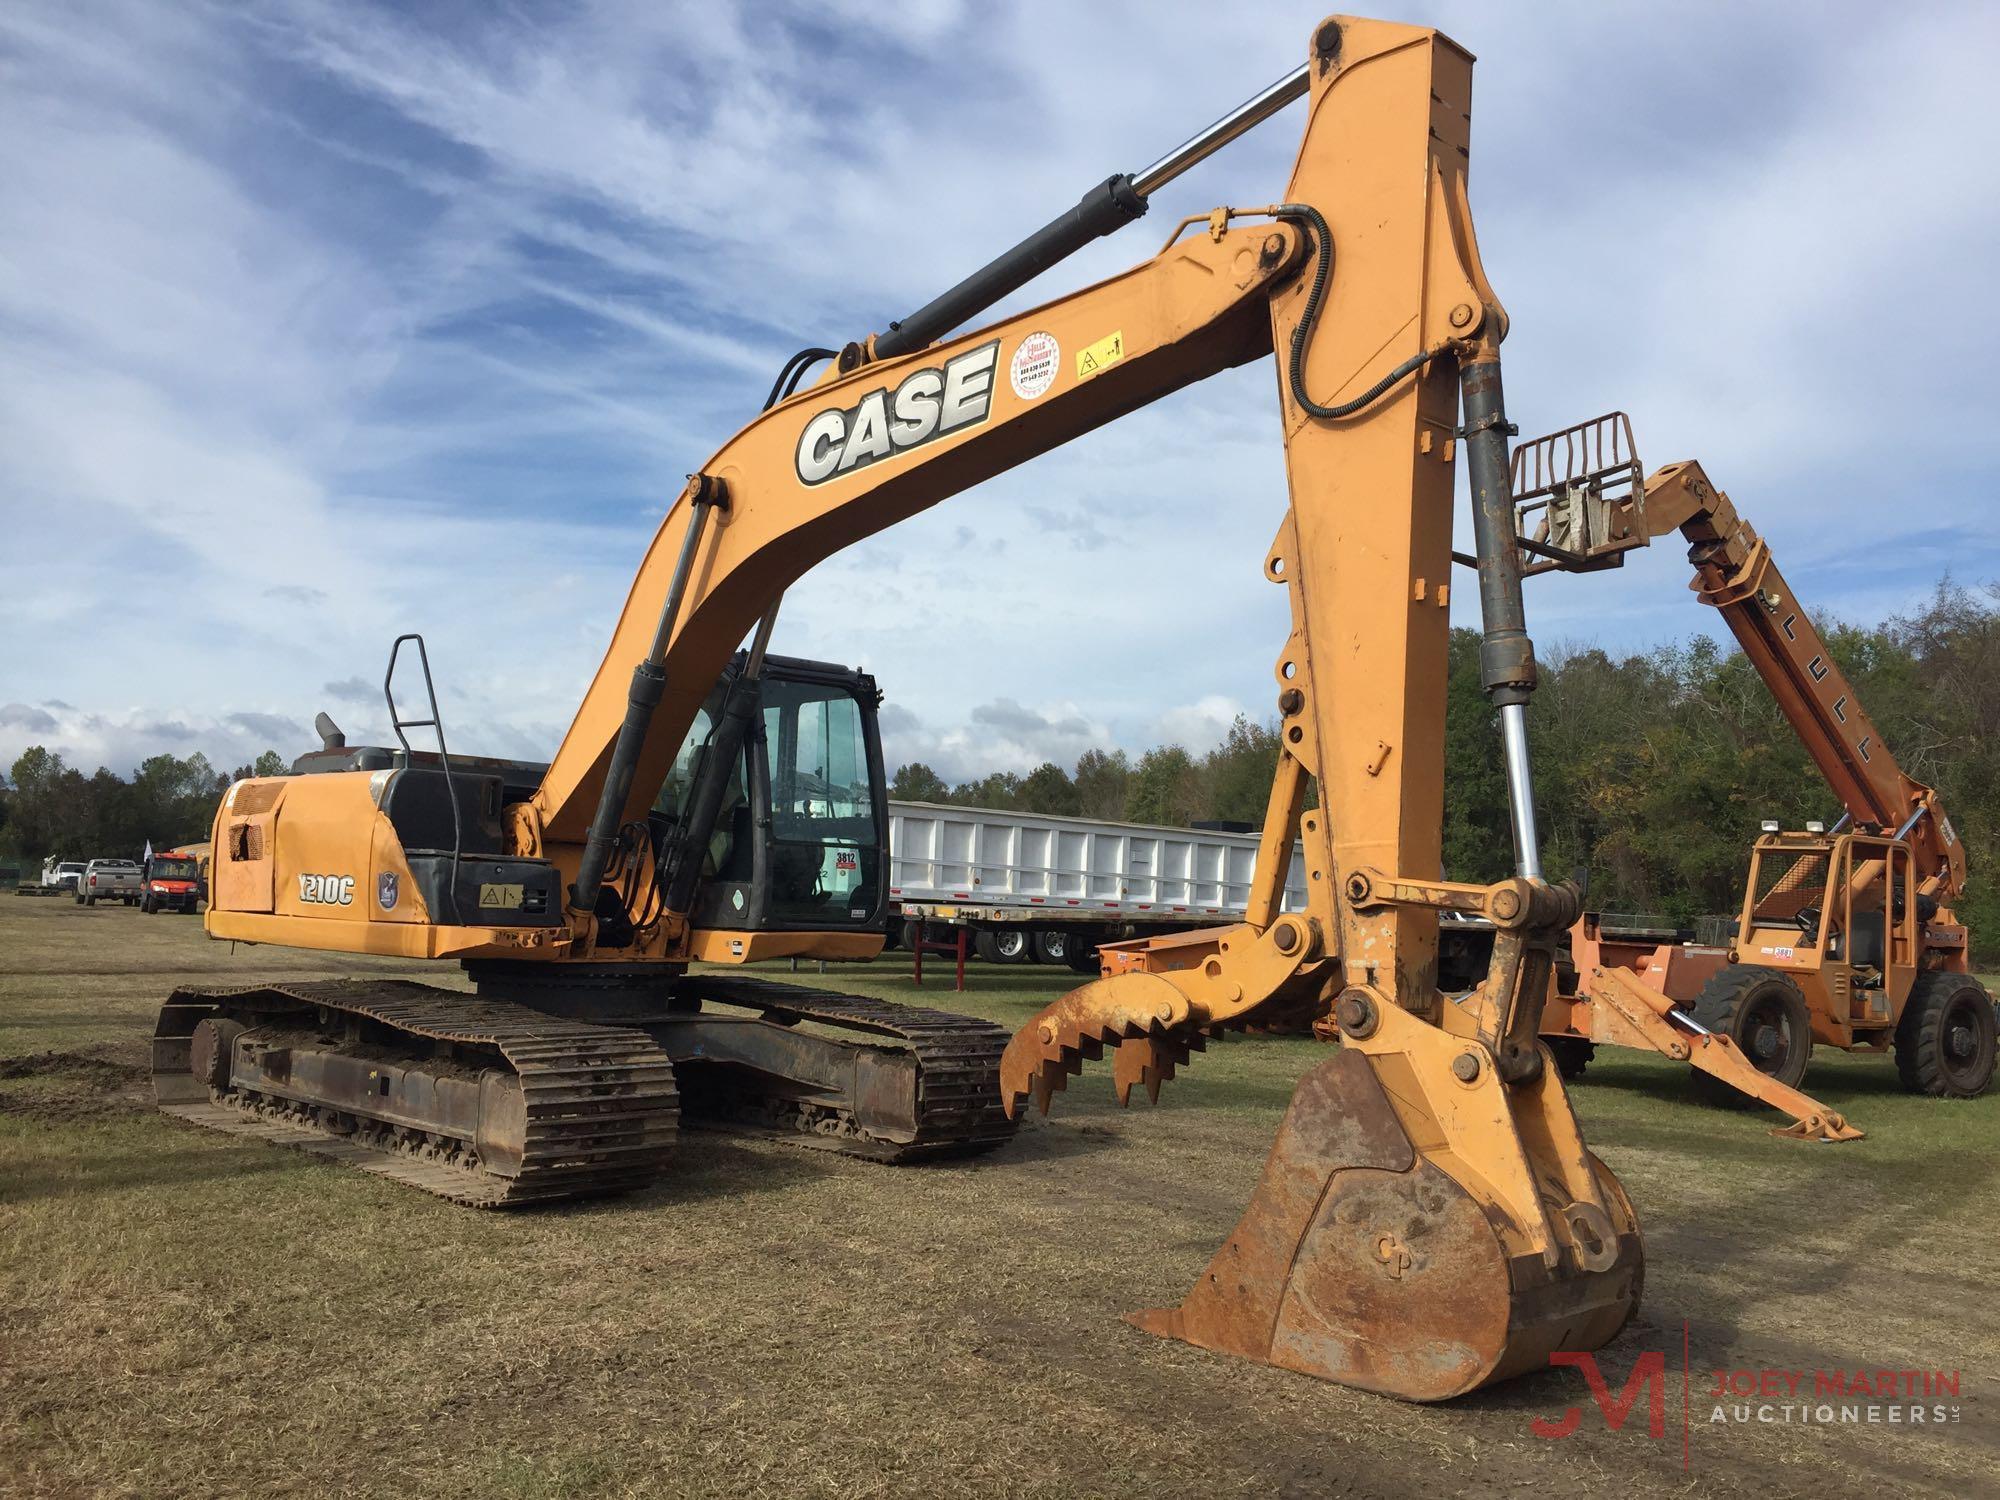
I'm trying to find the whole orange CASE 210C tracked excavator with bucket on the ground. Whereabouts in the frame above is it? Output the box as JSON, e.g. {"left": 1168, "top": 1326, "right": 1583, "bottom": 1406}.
{"left": 154, "top": 16, "right": 1644, "bottom": 1400}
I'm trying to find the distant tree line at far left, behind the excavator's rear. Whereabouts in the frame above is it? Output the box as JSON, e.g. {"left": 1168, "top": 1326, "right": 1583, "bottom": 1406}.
{"left": 0, "top": 746, "right": 288, "bottom": 864}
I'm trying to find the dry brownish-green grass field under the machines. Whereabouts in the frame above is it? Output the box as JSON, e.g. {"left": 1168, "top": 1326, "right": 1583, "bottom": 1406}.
{"left": 0, "top": 898, "right": 2000, "bottom": 1496}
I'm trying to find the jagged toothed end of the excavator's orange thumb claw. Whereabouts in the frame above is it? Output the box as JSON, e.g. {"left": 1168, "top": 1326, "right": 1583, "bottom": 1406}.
{"left": 1000, "top": 974, "right": 1202, "bottom": 1116}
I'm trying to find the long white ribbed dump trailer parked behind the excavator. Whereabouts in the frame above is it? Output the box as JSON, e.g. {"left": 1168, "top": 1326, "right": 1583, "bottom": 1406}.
{"left": 888, "top": 800, "right": 1306, "bottom": 972}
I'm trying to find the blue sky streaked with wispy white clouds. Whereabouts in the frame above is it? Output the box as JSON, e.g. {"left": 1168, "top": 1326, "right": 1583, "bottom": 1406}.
{"left": 0, "top": 0, "right": 2000, "bottom": 776}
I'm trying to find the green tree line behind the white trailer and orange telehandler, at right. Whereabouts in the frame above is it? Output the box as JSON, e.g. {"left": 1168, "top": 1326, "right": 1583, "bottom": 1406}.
{"left": 892, "top": 580, "right": 2000, "bottom": 958}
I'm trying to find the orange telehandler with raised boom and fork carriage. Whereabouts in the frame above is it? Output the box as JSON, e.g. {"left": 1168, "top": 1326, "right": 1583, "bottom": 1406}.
{"left": 1514, "top": 412, "right": 1996, "bottom": 1140}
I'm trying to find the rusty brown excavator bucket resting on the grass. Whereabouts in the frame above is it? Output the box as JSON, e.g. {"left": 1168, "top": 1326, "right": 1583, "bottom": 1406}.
{"left": 1128, "top": 1048, "right": 1644, "bottom": 1402}
